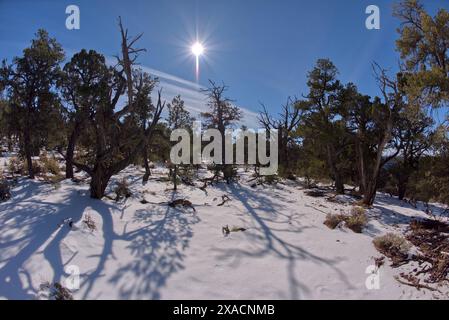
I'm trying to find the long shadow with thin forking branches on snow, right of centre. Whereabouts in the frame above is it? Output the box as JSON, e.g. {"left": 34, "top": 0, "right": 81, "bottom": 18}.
{"left": 217, "top": 184, "right": 353, "bottom": 299}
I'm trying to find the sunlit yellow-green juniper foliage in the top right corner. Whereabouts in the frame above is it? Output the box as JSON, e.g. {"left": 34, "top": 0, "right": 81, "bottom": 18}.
{"left": 394, "top": 0, "right": 449, "bottom": 106}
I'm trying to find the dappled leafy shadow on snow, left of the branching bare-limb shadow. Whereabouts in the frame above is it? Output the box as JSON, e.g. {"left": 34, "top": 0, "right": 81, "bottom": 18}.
{"left": 109, "top": 193, "right": 200, "bottom": 299}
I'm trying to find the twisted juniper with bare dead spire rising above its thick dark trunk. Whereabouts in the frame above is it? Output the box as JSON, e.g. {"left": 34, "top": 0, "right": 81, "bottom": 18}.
{"left": 69, "top": 20, "right": 165, "bottom": 199}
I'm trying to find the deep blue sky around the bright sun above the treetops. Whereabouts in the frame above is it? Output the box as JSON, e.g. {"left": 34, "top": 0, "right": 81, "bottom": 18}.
{"left": 0, "top": 0, "right": 449, "bottom": 124}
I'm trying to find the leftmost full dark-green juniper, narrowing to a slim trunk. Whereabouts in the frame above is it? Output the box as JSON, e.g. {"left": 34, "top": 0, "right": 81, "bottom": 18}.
{"left": 0, "top": 29, "right": 64, "bottom": 179}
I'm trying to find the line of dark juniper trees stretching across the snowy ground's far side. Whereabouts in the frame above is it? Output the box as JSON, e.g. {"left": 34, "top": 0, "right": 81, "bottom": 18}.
{"left": 0, "top": 0, "right": 449, "bottom": 206}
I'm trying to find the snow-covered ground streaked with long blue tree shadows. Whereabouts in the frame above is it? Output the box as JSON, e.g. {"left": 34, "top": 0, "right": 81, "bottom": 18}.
{"left": 0, "top": 160, "right": 448, "bottom": 299}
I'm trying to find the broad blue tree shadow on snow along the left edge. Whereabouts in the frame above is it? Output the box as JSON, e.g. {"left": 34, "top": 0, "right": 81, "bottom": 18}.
{"left": 0, "top": 180, "right": 89, "bottom": 299}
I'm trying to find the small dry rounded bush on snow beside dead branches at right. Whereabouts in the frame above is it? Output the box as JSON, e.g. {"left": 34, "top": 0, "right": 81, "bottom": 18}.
{"left": 373, "top": 233, "right": 411, "bottom": 263}
